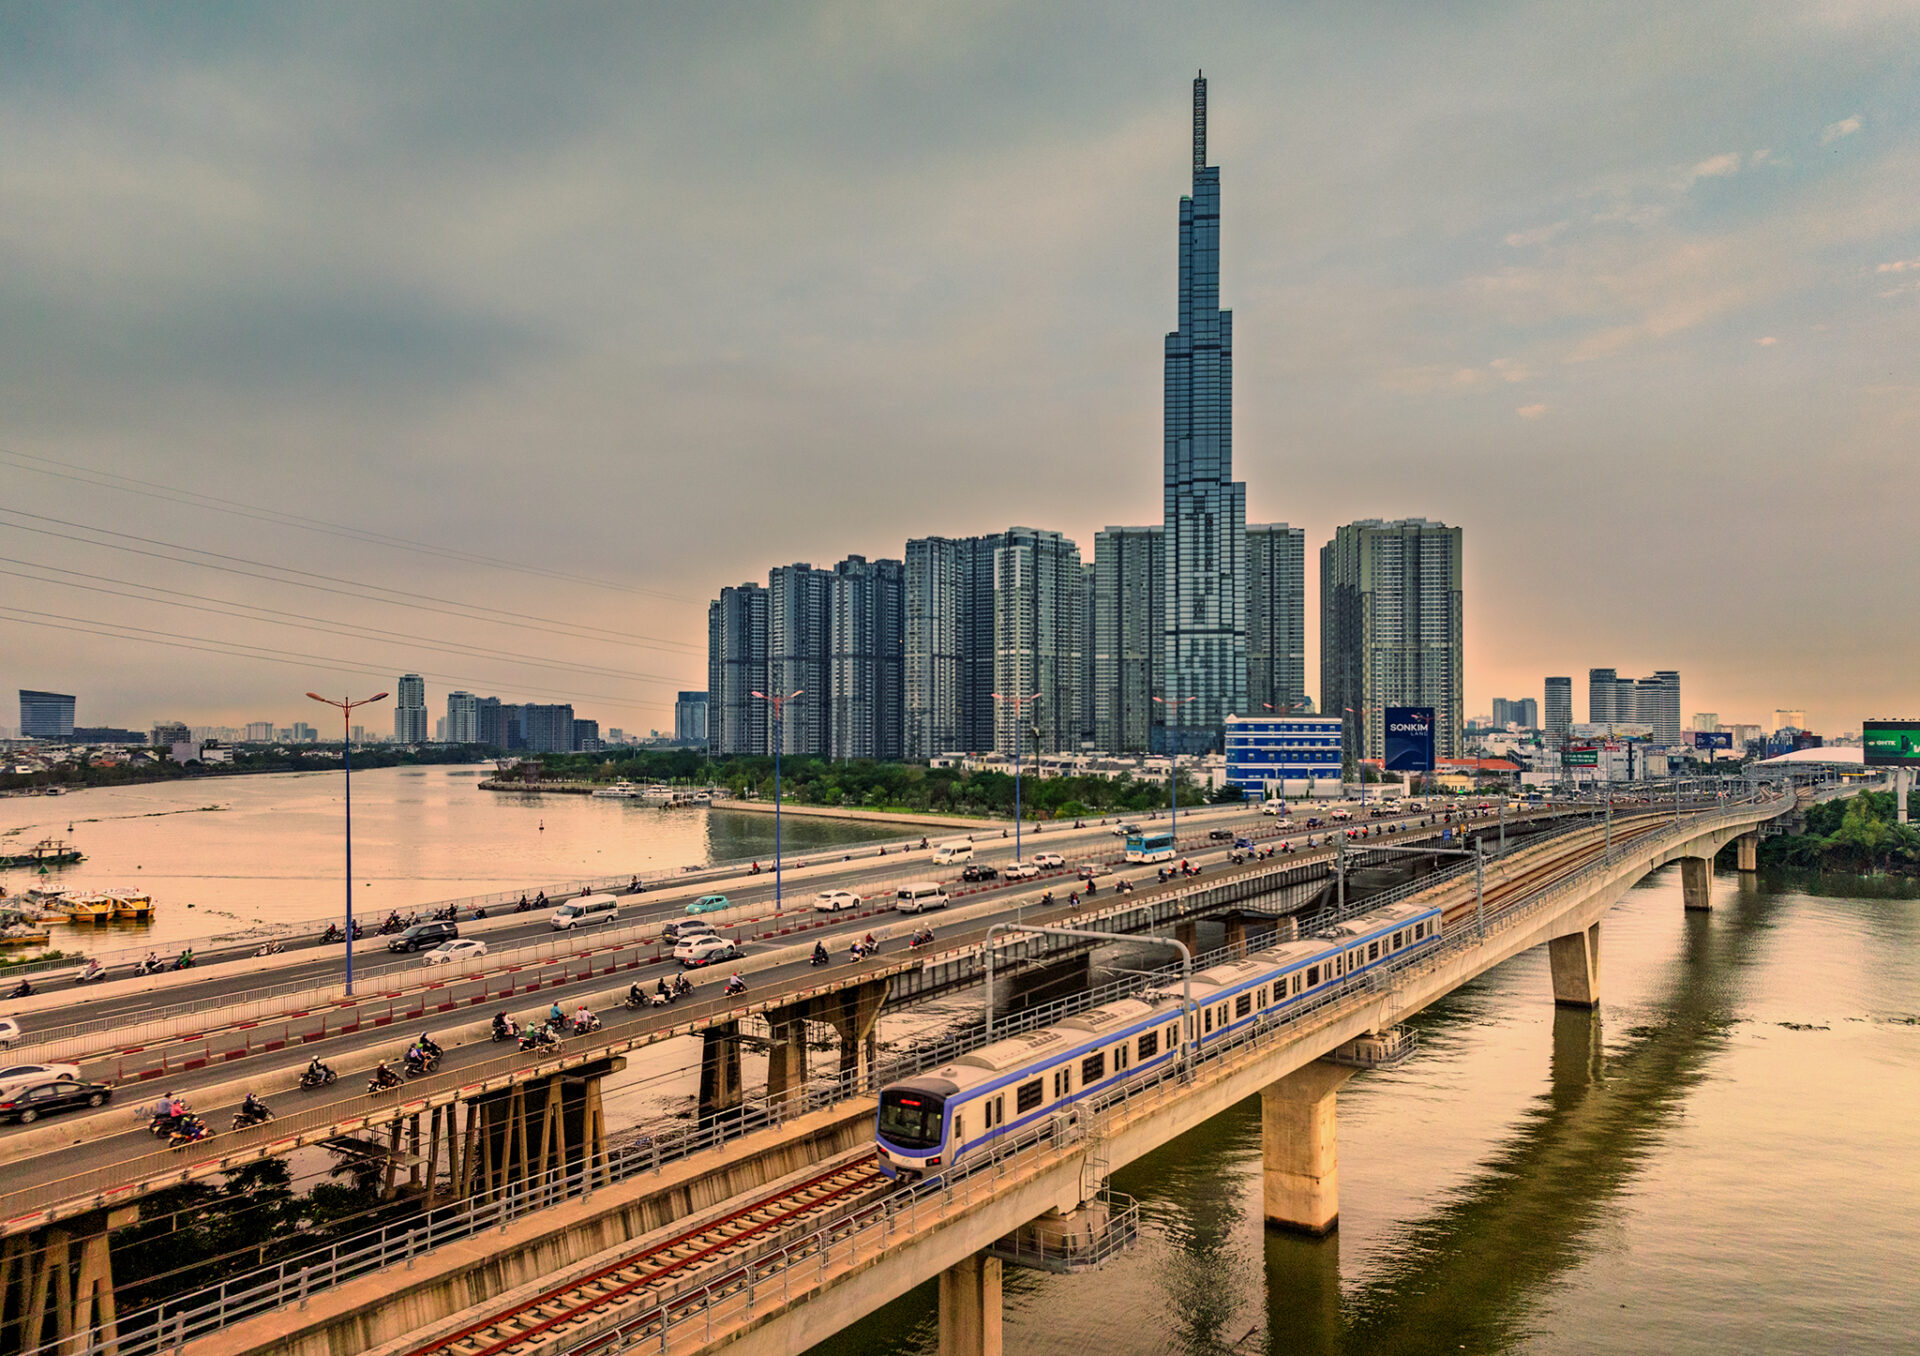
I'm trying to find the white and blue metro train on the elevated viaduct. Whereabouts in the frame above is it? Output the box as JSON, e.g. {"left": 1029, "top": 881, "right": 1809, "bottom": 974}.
{"left": 874, "top": 903, "right": 1440, "bottom": 1179}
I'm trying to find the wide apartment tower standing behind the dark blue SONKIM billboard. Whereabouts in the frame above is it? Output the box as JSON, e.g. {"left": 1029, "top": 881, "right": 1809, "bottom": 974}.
{"left": 1321, "top": 519, "right": 1463, "bottom": 759}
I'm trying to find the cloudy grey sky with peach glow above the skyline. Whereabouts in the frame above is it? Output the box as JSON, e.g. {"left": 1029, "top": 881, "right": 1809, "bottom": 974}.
{"left": 0, "top": 0, "right": 1920, "bottom": 732}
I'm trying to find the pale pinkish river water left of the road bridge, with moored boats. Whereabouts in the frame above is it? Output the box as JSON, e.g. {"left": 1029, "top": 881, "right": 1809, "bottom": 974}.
{"left": 0, "top": 766, "right": 910, "bottom": 951}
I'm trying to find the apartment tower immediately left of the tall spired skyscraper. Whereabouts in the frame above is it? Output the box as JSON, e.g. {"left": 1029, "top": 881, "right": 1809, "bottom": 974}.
{"left": 1089, "top": 528, "right": 1167, "bottom": 753}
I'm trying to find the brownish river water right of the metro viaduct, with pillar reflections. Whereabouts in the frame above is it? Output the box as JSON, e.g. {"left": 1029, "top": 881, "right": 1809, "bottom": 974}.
{"left": 816, "top": 866, "right": 1920, "bottom": 1356}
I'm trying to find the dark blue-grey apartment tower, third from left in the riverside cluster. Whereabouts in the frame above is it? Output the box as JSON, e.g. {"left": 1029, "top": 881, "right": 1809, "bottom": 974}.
{"left": 825, "top": 555, "right": 906, "bottom": 759}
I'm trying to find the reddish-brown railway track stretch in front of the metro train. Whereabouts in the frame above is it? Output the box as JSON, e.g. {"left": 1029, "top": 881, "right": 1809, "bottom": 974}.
{"left": 407, "top": 1154, "right": 893, "bottom": 1356}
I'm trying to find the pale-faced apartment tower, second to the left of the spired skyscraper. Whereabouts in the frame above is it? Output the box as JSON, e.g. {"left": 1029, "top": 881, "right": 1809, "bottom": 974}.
{"left": 989, "top": 528, "right": 1085, "bottom": 755}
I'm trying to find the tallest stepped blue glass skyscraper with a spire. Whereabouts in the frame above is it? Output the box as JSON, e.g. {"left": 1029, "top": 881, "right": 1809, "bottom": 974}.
{"left": 1164, "top": 75, "right": 1246, "bottom": 751}
